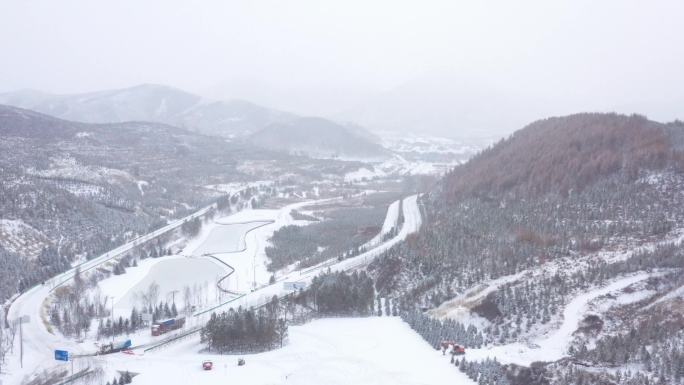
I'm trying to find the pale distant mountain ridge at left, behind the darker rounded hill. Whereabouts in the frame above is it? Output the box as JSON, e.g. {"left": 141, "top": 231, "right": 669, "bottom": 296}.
{"left": 0, "top": 84, "right": 294, "bottom": 137}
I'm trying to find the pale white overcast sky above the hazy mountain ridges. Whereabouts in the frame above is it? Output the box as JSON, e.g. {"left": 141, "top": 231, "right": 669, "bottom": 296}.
{"left": 0, "top": 0, "right": 684, "bottom": 136}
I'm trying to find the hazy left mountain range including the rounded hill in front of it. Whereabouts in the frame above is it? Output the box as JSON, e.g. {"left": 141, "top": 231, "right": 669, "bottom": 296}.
{"left": 0, "top": 84, "right": 400, "bottom": 159}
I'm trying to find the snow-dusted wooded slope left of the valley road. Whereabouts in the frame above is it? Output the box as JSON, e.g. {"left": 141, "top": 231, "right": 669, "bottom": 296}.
{"left": 0, "top": 105, "right": 358, "bottom": 301}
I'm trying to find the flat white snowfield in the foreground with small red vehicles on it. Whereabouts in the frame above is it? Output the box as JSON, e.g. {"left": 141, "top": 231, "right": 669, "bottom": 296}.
{"left": 108, "top": 317, "right": 473, "bottom": 385}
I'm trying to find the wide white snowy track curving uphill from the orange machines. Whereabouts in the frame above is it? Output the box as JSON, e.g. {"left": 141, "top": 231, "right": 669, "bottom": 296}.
{"left": 466, "top": 273, "right": 652, "bottom": 366}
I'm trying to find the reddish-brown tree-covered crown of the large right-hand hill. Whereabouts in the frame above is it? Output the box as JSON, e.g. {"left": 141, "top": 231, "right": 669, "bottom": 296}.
{"left": 444, "top": 113, "right": 684, "bottom": 198}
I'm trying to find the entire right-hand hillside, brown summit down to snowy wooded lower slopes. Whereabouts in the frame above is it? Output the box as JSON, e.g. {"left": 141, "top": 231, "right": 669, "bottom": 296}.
{"left": 371, "top": 114, "right": 684, "bottom": 385}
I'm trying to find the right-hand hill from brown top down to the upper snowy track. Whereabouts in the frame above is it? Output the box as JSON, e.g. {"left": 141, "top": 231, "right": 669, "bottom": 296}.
{"left": 377, "top": 114, "right": 684, "bottom": 305}
